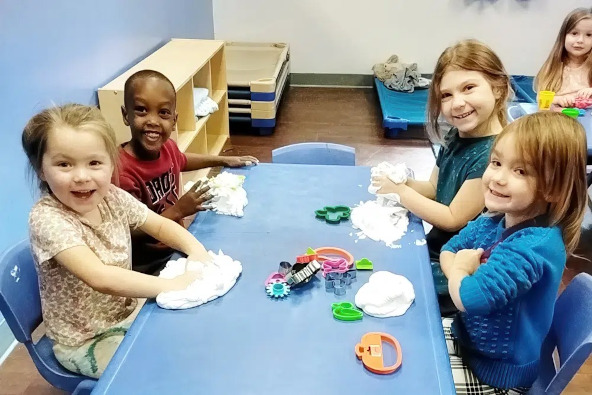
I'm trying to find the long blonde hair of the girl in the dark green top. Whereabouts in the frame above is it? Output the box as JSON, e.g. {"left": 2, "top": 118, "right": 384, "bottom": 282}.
{"left": 427, "top": 40, "right": 512, "bottom": 142}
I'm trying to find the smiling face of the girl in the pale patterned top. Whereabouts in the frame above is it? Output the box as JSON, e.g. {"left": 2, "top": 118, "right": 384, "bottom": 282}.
{"left": 40, "top": 126, "right": 113, "bottom": 217}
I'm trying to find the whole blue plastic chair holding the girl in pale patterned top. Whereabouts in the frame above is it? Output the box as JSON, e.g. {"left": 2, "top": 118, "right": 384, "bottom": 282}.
{"left": 0, "top": 240, "right": 96, "bottom": 394}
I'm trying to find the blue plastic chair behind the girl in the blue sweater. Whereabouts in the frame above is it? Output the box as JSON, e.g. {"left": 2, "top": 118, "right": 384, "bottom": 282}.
{"left": 529, "top": 273, "right": 592, "bottom": 395}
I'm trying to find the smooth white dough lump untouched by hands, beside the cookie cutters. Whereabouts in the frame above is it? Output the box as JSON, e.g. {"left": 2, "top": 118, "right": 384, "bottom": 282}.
{"left": 355, "top": 271, "right": 415, "bottom": 318}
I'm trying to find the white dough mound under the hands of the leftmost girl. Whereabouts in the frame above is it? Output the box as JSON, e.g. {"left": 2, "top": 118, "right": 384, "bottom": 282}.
{"left": 156, "top": 251, "right": 243, "bottom": 310}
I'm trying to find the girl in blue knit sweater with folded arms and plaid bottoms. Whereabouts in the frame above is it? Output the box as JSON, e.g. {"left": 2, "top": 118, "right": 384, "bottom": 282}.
{"left": 440, "top": 112, "right": 587, "bottom": 394}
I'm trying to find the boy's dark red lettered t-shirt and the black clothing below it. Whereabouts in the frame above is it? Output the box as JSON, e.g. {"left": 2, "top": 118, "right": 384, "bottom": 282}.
{"left": 119, "top": 139, "right": 187, "bottom": 274}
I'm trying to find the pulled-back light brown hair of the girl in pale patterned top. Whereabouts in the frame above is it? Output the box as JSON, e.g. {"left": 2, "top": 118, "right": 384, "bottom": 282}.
{"left": 21, "top": 104, "right": 118, "bottom": 192}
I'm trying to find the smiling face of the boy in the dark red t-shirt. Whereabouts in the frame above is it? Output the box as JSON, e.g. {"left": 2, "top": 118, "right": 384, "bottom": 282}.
{"left": 123, "top": 77, "right": 177, "bottom": 159}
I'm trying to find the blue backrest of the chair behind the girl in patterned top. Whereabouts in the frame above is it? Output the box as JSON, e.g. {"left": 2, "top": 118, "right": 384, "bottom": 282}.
{"left": 0, "top": 240, "right": 43, "bottom": 343}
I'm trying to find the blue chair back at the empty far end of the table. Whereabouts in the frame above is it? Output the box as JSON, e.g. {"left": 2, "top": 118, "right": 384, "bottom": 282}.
{"left": 271, "top": 143, "right": 356, "bottom": 166}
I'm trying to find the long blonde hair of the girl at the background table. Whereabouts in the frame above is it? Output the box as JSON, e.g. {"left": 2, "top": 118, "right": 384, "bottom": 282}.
{"left": 534, "top": 8, "right": 592, "bottom": 92}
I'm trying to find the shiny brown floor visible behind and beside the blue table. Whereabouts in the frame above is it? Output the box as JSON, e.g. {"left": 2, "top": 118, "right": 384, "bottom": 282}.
{"left": 0, "top": 88, "right": 592, "bottom": 394}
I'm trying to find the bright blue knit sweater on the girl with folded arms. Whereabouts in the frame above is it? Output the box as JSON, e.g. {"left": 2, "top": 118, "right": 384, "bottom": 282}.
{"left": 442, "top": 215, "right": 567, "bottom": 388}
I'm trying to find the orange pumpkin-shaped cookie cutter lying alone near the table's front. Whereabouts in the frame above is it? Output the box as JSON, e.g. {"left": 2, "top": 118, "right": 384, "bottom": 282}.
{"left": 356, "top": 332, "right": 403, "bottom": 374}
